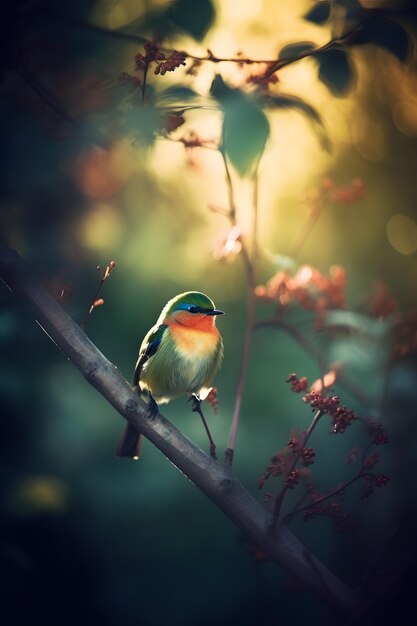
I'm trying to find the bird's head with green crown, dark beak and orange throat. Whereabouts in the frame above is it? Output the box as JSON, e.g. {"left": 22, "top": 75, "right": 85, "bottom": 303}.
{"left": 161, "top": 291, "right": 223, "bottom": 329}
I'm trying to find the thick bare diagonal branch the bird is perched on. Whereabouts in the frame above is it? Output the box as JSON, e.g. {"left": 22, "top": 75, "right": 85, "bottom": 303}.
{"left": 0, "top": 245, "right": 357, "bottom": 615}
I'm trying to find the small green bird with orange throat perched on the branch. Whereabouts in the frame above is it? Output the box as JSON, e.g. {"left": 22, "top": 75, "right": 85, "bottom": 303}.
{"left": 116, "top": 291, "right": 223, "bottom": 460}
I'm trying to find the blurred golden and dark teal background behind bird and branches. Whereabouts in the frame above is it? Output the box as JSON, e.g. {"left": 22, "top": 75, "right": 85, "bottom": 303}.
{"left": 0, "top": 0, "right": 417, "bottom": 626}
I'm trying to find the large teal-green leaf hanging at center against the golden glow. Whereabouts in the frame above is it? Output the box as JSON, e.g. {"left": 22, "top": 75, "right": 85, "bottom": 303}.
{"left": 211, "top": 75, "right": 269, "bottom": 176}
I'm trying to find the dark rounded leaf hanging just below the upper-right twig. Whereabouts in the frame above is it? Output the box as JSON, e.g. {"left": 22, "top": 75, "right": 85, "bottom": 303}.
{"left": 315, "top": 48, "right": 355, "bottom": 96}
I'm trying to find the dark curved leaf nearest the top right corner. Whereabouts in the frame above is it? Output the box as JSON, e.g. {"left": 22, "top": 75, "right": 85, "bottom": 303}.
{"left": 352, "top": 17, "right": 411, "bottom": 62}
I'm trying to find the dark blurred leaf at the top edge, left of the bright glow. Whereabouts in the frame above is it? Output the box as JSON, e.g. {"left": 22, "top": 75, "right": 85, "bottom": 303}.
{"left": 165, "top": 0, "right": 215, "bottom": 41}
